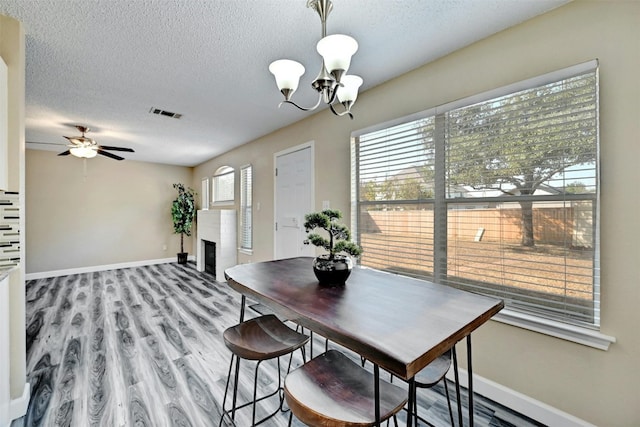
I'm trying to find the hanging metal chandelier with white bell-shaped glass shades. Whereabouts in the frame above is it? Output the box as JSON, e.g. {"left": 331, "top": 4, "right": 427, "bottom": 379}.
{"left": 269, "top": 0, "right": 362, "bottom": 119}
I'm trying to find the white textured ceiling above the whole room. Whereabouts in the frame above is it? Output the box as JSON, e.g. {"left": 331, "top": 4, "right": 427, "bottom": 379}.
{"left": 0, "top": 0, "right": 569, "bottom": 166}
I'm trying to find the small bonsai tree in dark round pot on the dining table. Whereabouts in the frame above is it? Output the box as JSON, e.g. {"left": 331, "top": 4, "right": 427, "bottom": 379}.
{"left": 304, "top": 209, "right": 362, "bottom": 285}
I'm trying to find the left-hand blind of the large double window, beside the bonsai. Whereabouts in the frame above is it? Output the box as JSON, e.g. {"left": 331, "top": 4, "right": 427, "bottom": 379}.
{"left": 357, "top": 117, "right": 434, "bottom": 275}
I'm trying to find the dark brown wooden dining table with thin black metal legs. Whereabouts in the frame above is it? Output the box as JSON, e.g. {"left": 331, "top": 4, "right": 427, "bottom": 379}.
{"left": 225, "top": 257, "right": 504, "bottom": 426}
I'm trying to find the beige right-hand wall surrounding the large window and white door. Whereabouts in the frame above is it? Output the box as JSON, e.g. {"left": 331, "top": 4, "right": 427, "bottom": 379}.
{"left": 193, "top": 0, "right": 640, "bottom": 426}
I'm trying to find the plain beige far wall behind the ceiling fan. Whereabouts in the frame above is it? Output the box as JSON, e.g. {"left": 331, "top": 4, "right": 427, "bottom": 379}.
{"left": 26, "top": 147, "right": 193, "bottom": 273}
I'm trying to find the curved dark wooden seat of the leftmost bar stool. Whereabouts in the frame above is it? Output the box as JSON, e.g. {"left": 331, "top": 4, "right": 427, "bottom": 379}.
{"left": 223, "top": 314, "right": 309, "bottom": 360}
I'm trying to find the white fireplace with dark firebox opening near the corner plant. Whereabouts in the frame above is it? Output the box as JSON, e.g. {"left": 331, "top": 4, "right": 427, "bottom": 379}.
{"left": 196, "top": 209, "right": 238, "bottom": 282}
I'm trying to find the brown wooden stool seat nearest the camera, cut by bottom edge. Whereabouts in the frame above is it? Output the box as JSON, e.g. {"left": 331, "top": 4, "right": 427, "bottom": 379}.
{"left": 284, "top": 350, "right": 407, "bottom": 427}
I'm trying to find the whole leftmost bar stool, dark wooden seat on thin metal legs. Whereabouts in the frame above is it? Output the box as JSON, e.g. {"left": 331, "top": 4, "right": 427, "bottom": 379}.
{"left": 219, "top": 314, "right": 309, "bottom": 426}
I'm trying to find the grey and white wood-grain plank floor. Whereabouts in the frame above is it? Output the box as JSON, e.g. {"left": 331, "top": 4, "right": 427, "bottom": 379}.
{"left": 12, "top": 263, "right": 539, "bottom": 427}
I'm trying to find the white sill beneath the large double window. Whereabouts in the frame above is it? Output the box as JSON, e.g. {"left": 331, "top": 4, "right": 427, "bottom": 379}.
{"left": 492, "top": 309, "right": 616, "bottom": 351}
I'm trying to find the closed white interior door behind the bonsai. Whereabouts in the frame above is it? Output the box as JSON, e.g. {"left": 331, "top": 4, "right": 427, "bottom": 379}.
{"left": 274, "top": 143, "right": 315, "bottom": 259}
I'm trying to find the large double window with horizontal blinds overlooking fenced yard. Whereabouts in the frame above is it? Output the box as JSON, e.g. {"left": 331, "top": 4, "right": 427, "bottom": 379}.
{"left": 352, "top": 61, "right": 600, "bottom": 329}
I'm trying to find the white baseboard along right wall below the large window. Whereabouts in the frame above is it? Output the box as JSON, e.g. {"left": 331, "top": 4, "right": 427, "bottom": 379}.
{"left": 447, "top": 368, "right": 596, "bottom": 427}
